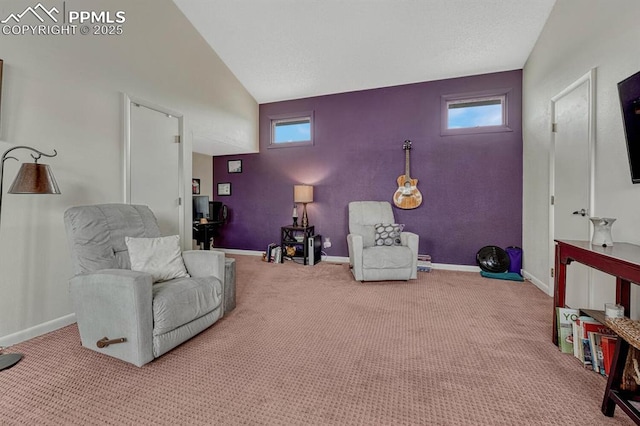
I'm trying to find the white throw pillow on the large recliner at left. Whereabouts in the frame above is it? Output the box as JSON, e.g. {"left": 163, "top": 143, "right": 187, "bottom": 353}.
{"left": 124, "top": 235, "right": 189, "bottom": 283}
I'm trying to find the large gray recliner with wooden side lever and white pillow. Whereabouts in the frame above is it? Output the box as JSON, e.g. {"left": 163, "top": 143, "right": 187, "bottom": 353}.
{"left": 64, "top": 204, "right": 225, "bottom": 367}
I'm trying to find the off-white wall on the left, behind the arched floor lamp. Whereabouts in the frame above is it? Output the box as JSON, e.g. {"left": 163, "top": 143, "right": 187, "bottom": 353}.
{"left": 0, "top": 0, "right": 258, "bottom": 346}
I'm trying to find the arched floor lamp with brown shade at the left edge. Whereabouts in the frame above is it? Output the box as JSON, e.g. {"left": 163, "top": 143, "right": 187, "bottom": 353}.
{"left": 0, "top": 146, "right": 60, "bottom": 371}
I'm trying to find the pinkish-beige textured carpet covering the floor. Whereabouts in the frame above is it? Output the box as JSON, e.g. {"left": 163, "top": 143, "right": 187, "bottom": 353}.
{"left": 0, "top": 256, "right": 631, "bottom": 426}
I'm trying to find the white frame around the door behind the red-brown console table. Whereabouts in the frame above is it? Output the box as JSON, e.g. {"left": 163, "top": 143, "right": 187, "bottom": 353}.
{"left": 548, "top": 68, "right": 596, "bottom": 303}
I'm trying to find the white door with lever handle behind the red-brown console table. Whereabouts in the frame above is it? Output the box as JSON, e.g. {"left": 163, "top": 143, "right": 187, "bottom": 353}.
{"left": 552, "top": 73, "right": 594, "bottom": 308}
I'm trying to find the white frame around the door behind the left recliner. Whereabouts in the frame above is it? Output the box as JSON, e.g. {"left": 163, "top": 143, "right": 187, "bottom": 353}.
{"left": 122, "top": 93, "right": 191, "bottom": 249}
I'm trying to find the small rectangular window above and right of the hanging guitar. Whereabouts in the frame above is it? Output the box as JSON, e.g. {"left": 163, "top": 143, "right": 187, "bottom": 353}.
{"left": 441, "top": 92, "right": 511, "bottom": 135}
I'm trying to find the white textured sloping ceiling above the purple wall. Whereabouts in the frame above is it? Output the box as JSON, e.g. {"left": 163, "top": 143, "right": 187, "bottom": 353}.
{"left": 174, "top": 0, "right": 556, "bottom": 103}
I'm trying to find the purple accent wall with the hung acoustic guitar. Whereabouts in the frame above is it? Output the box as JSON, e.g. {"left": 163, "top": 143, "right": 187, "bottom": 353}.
{"left": 213, "top": 70, "right": 522, "bottom": 265}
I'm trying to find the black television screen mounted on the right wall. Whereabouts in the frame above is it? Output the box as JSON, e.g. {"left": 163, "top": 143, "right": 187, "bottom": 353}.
{"left": 618, "top": 71, "right": 640, "bottom": 183}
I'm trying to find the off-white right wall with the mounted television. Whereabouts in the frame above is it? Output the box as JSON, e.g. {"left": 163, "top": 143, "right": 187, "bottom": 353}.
{"left": 523, "top": 0, "right": 640, "bottom": 311}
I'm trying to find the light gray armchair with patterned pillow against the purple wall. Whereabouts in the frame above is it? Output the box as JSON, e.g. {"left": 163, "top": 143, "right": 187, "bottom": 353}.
{"left": 347, "top": 201, "right": 419, "bottom": 281}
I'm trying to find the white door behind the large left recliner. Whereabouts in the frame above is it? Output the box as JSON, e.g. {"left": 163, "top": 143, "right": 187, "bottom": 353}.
{"left": 128, "top": 102, "right": 182, "bottom": 235}
